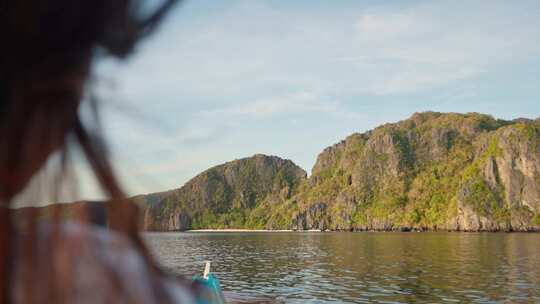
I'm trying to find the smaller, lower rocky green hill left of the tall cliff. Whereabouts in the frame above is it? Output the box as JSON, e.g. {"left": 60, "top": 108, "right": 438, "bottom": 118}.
{"left": 134, "top": 154, "right": 306, "bottom": 231}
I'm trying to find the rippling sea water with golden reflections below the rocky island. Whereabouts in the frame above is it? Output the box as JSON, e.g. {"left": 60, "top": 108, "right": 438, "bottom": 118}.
{"left": 146, "top": 232, "right": 540, "bottom": 303}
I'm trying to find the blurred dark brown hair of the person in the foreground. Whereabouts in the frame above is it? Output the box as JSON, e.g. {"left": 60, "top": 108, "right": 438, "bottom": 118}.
{"left": 0, "top": 0, "right": 178, "bottom": 304}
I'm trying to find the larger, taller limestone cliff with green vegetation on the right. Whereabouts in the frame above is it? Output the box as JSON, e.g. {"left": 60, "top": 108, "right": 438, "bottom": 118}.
{"left": 291, "top": 112, "right": 540, "bottom": 231}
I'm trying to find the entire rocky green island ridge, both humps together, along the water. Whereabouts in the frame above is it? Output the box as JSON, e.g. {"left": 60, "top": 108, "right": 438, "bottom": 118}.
{"left": 135, "top": 112, "right": 540, "bottom": 231}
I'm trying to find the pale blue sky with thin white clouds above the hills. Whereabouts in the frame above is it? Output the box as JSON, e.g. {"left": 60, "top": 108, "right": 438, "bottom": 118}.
{"left": 42, "top": 0, "right": 540, "bottom": 202}
